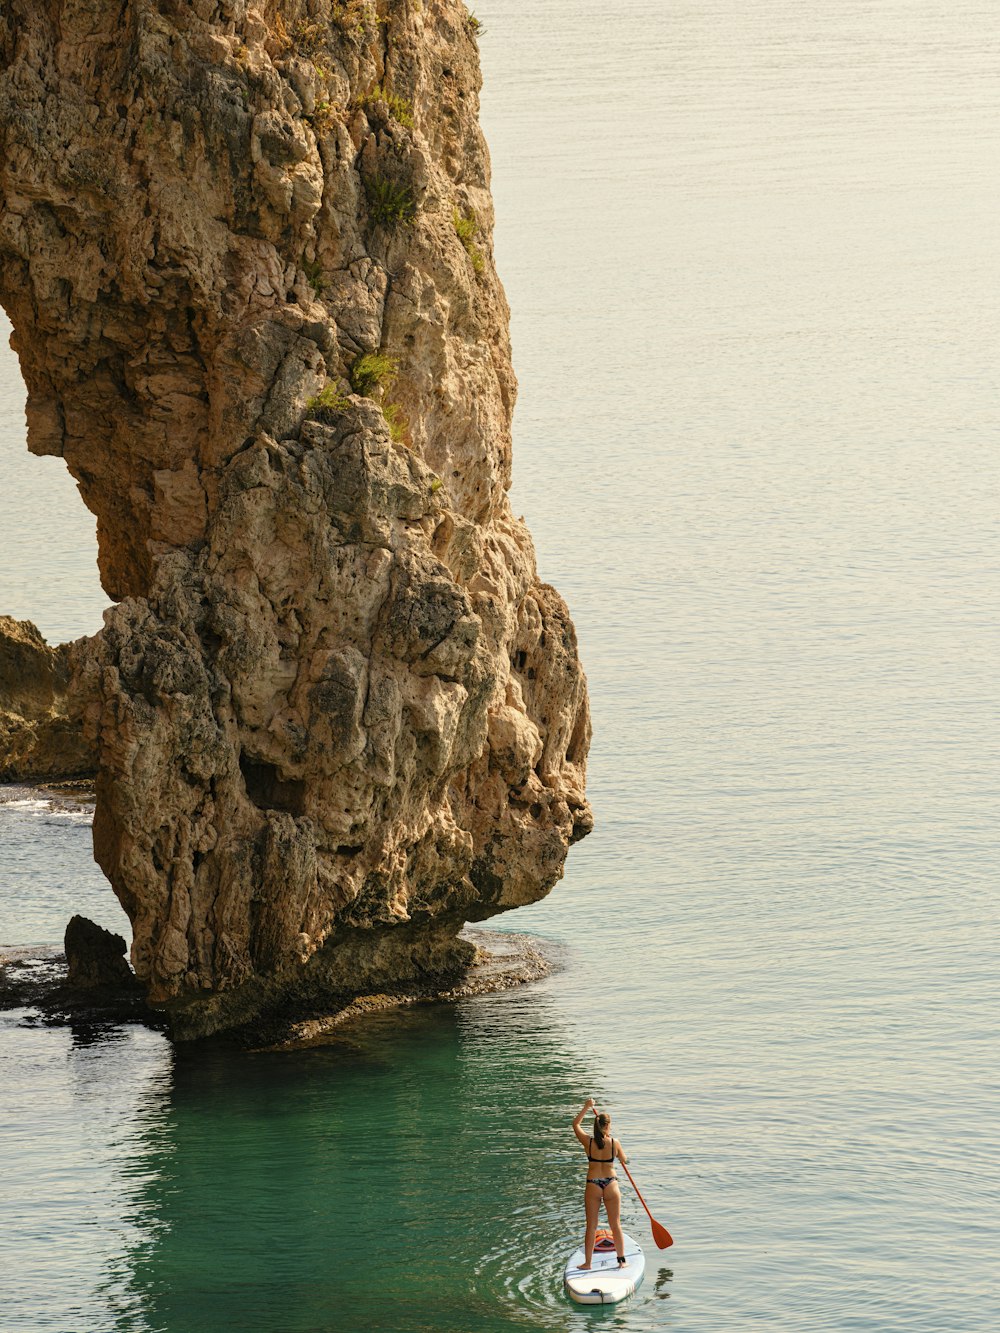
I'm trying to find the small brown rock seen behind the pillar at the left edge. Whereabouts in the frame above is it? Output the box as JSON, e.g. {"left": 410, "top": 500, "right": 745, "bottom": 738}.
{"left": 0, "top": 616, "right": 97, "bottom": 782}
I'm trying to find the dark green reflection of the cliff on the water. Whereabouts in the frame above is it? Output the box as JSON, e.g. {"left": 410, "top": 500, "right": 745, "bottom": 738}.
{"left": 74, "top": 990, "right": 624, "bottom": 1333}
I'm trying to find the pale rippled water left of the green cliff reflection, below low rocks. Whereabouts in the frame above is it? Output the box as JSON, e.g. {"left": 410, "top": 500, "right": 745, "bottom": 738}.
{"left": 0, "top": 1010, "right": 169, "bottom": 1333}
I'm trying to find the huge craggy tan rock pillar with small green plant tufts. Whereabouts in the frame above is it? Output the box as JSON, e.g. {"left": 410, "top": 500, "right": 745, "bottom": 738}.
{"left": 0, "top": 0, "right": 592, "bottom": 1036}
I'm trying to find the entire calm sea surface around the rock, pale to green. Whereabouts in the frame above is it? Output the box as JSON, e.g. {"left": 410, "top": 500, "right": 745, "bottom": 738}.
{"left": 0, "top": 0, "right": 1000, "bottom": 1333}
